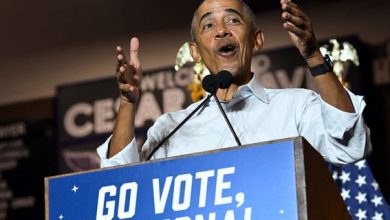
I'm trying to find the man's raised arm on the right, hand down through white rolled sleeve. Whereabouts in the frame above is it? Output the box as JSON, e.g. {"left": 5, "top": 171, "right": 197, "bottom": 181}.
{"left": 281, "top": 0, "right": 371, "bottom": 164}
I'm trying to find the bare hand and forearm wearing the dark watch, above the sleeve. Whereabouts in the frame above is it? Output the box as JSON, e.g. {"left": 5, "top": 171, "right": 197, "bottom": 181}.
{"left": 281, "top": 0, "right": 355, "bottom": 113}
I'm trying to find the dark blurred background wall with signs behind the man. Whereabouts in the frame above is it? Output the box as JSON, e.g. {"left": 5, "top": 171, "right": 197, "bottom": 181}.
{"left": 0, "top": 0, "right": 390, "bottom": 219}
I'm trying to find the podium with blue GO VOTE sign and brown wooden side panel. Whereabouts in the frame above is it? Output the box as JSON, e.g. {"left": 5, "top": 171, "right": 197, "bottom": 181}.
{"left": 45, "top": 137, "right": 351, "bottom": 220}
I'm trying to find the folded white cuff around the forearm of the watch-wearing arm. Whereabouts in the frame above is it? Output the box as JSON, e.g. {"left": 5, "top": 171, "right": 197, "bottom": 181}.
{"left": 320, "top": 89, "right": 366, "bottom": 139}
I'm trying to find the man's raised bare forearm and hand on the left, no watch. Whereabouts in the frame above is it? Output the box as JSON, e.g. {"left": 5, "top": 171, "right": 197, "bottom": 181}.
{"left": 107, "top": 38, "right": 142, "bottom": 158}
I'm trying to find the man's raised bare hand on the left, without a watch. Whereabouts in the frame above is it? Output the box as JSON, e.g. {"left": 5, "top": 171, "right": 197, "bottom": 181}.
{"left": 115, "top": 38, "right": 142, "bottom": 104}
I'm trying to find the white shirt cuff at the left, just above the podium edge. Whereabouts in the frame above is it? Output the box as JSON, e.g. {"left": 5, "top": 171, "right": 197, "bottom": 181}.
{"left": 96, "top": 135, "right": 140, "bottom": 168}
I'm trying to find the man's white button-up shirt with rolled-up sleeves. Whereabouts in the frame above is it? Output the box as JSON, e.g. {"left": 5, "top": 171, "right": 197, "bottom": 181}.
{"left": 97, "top": 77, "right": 370, "bottom": 167}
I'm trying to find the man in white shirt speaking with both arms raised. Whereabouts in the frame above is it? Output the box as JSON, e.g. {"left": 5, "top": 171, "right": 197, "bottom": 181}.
{"left": 98, "top": 0, "right": 370, "bottom": 166}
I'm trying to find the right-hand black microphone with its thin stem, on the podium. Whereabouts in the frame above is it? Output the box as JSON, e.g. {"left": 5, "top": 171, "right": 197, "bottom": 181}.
{"left": 210, "top": 70, "right": 242, "bottom": 146}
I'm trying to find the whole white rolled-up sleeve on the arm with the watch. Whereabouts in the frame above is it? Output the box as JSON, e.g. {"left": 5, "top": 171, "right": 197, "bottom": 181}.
{"left": 302, "top": 90, "right": 371, "bottom": 165}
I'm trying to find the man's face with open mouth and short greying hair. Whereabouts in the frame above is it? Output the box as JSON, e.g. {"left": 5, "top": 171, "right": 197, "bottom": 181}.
{"left": 193, "top": 0, "right": 255, "bottom": 78}
